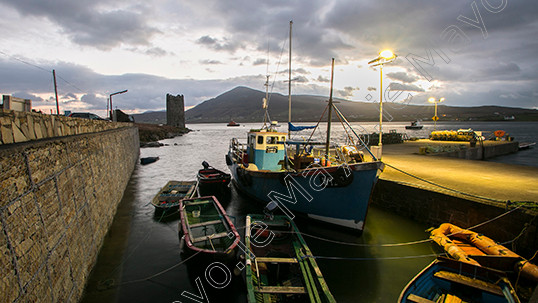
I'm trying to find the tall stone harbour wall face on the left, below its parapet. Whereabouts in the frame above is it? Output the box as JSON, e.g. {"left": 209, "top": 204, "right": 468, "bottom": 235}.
{"left": 0, "top": 127, "right": 139, "bottom": 302}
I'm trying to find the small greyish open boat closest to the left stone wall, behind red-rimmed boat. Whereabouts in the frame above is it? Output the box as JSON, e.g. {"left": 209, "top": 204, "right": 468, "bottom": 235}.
{"left": 151, "top": 181, "right": 197, "bottom": 211}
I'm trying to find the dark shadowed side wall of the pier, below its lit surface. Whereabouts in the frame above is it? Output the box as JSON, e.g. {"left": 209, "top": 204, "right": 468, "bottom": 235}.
{"left": 372, "top": 180, "right": 538, "bottom": 258}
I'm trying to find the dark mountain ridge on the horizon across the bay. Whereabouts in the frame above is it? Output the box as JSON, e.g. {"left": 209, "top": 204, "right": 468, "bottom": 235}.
{"left": 135, "top": 86, "right": 538, "bottom": 123}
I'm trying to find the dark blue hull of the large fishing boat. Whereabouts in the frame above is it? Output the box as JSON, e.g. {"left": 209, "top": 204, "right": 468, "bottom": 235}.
{"left": 229, "top": 154, "right": 384, "bottom": 232}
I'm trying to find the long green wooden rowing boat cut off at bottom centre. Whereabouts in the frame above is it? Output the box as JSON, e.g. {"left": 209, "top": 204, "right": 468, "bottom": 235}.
{"left": 245, "top": 215, "right": 336, "bottom": 303}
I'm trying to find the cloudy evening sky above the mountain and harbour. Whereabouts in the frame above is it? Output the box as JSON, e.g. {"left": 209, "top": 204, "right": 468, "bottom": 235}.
{"left": 0, "top": 0, "right": 538, "bottom": 115}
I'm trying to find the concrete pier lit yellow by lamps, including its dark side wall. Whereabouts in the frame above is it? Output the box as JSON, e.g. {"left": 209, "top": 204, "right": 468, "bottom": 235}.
{"left": 373, "top": 141, "right": 538, "bottom": 257}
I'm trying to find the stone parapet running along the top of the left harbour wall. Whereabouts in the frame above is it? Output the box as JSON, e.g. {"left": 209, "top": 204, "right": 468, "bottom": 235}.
{"left": 0, "top": 109, "right": 132, "bottom": 144}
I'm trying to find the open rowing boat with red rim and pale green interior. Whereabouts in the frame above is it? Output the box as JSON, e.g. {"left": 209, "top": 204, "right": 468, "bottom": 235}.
{"left": 179, "top": 196, "right": 240, "bottom": 262}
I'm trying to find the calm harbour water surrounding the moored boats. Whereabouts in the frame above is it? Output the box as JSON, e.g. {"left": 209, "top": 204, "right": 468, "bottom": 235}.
{"left": 84, "top": 122, "right": 538, "bottom": 302}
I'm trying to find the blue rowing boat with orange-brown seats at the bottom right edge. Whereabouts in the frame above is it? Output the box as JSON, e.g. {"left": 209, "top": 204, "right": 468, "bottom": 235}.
{"left": 398, "top": 257, "right": 520, "bottom": 303}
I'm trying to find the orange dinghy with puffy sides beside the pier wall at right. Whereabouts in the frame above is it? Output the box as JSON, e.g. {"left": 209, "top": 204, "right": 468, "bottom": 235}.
{"left": 430, "top": 223, "right": 538, "bottom": 282}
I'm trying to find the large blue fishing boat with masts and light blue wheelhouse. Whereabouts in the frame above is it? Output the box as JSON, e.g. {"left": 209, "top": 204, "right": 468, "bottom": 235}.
{"left": 226, "top": 24, "right": 384, "bottom": 234}
